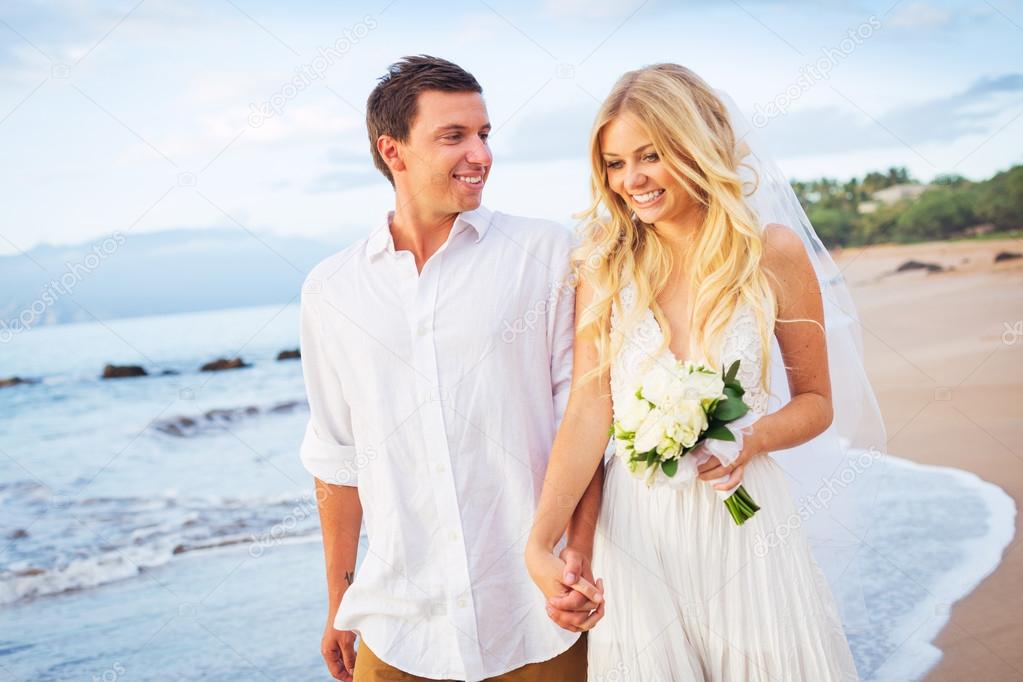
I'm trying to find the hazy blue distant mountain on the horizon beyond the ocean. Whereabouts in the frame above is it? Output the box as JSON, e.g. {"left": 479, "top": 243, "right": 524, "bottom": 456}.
{"left": 0, "top": 228, "right": 344, "bottom": 328}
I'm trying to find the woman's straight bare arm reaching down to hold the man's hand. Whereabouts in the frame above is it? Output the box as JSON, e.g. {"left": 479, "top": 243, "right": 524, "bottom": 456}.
{"left": 526, "top": 282, "right": 612, "bottom": 602}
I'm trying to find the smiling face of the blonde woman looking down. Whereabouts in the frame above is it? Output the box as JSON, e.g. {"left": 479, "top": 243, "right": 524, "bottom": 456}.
{"left": 599, "top": 112, "right": 693, "bottom": 225}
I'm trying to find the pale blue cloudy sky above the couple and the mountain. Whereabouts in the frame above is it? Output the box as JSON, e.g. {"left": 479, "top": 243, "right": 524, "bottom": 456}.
{"left": 0, "top": 0, "right": 1023, "bottom": 254}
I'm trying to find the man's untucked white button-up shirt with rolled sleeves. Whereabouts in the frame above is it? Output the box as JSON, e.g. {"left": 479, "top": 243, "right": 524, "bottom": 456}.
{"left": 301, "top": 207, "right": 579, "bottom": 680}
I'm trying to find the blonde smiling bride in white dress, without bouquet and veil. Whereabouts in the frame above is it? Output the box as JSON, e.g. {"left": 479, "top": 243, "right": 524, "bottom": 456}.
{"left": 526, "top": 64, "right": 856, "bottom": 681}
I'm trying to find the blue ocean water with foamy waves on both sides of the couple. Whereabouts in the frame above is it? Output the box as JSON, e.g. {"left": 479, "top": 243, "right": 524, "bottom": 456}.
{"left": 0, "top": 304, "right": 1016, "bottom": 680}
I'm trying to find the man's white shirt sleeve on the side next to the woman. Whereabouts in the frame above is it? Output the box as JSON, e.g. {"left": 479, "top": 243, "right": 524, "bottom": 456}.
{"left": 547, "top": 228, "right": 575, "bottom": 425}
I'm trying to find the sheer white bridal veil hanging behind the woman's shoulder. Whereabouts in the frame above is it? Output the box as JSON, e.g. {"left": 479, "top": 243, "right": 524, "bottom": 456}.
{"left": 717, "top": 91, "right": 886, "bottom": 634}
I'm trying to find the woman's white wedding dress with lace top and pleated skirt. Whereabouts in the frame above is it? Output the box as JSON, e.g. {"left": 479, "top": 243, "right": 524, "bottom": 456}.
{"left": 587, "top": 284, "right": 857, "bottom": 682}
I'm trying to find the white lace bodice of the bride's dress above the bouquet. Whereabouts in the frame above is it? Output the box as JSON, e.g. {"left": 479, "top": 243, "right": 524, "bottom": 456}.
{"left": 611, "top": 282, "right": 768, "bottom": 419}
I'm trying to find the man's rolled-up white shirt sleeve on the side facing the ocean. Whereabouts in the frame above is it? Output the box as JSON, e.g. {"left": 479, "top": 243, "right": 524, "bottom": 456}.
{"left": 299, "top": 275, "right": 358, "bottom": 486}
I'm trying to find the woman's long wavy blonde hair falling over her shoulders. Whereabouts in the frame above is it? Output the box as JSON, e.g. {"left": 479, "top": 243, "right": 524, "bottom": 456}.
{"left": 573, "top": 63, "right": 776, "bottom": 391}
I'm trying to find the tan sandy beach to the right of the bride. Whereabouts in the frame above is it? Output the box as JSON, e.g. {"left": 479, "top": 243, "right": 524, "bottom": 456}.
{"left": 835, "top": 239, "right": 1023, "bottom": 681}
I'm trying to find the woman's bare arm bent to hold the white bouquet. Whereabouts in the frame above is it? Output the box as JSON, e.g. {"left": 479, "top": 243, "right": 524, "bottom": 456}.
{"left": 700, "top": 225, "right": 833, "bottom": 490}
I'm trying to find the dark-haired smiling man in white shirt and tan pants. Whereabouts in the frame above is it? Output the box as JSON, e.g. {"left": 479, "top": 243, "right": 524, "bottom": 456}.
{"left": 301, "top": 56, "right": 603, "bottom": 682}
